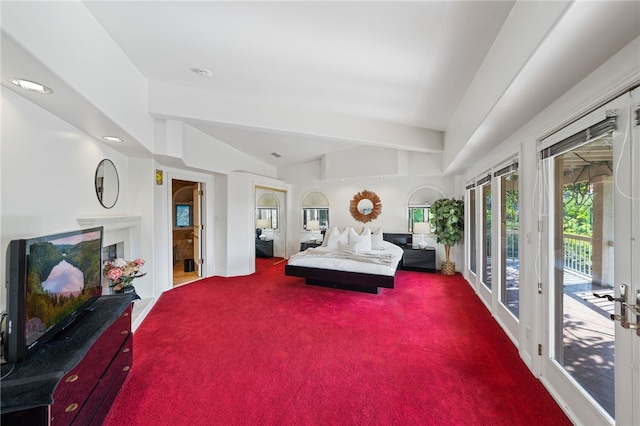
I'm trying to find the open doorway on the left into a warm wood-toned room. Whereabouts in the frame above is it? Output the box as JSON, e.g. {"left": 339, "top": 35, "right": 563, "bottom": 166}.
{"left": 171, "top": 179, "right": 203, "bottom": 286}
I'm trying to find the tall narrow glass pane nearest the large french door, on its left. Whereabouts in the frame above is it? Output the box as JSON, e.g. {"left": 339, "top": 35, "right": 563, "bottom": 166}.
{"left": 500, "top": 172, "right": 520, "bottom": 318}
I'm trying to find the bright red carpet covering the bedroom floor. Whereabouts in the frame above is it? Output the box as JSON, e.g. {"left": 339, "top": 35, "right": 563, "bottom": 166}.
{"left": 105, "top": 262, "right": 571, "bottom": 426}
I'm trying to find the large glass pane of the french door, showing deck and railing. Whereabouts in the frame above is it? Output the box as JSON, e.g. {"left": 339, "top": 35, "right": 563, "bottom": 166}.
{"left": 553, "top": 135, "right": 615, "bottom": 416}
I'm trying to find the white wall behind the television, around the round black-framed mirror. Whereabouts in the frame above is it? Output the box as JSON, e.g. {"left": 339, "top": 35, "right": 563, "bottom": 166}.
{"left": 0, "top": 87, "right": 134, "bottom": 306}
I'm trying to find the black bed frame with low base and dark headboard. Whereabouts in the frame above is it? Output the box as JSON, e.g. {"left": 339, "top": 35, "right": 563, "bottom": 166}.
{"left": 284, "top": 233, "right": 411, "bottom": 294}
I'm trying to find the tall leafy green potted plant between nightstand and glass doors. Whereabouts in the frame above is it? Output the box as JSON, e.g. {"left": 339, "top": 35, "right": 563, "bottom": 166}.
{"left": 429, "top": 198, "right": 464, "bottom": 275}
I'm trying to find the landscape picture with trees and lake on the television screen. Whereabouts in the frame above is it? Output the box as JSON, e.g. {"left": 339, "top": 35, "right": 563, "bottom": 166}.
{"left": 25, "top": 231, "right": 102, "bottom": 346}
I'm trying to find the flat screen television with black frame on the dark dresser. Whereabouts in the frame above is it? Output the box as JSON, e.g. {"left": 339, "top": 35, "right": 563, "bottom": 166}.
{"left": 3, "top": 227, "right": 103, "bottom": 362}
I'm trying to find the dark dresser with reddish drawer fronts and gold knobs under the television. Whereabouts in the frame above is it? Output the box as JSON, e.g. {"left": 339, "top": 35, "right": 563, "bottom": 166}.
{"left": 2, "top": 295, "right": 133, "bottom": 426}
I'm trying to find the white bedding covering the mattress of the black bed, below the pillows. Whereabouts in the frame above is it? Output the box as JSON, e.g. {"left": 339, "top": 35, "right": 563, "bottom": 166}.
{"left": 288, "top": 241, "right": 403, "bottom": 276}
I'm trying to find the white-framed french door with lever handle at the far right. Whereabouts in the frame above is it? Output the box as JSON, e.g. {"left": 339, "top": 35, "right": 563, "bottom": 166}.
{"left": 539, "top": 90, "right": 640, "bottom": 425}
